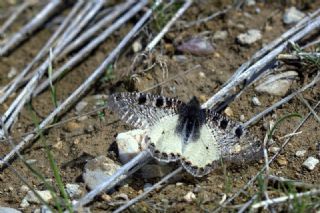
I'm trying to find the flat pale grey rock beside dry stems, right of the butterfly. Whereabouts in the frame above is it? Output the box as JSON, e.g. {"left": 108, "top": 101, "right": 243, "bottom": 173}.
{"left": 255, "top": 71, "right": 298, "bottom": 96}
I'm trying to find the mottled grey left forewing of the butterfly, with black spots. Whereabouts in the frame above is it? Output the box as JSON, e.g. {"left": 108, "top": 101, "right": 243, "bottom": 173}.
{"left": 108, "top": 92, "right": 184, "bottom": 129}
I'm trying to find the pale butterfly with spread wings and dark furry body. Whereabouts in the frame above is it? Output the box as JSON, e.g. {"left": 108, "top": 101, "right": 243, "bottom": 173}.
{"left": 108, "top": 92, "right": 262, "bottom": 177}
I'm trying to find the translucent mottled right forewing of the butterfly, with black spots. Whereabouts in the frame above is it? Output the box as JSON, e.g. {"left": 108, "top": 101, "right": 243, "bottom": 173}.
{"left": 206, "top": 110, "right": 263, "bottom": 163}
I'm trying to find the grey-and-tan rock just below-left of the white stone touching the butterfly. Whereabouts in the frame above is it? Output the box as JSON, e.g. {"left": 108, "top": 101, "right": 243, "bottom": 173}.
{"left": 82, "top": 156, "right": 120, "bottom": 189}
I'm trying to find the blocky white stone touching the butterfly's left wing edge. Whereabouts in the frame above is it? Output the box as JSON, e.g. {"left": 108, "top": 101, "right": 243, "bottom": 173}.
{"left": 116, "top": 129, "right": 146, "bottom": 164}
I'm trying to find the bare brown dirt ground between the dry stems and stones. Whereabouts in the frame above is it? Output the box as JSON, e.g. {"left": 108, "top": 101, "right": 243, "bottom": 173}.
{"left": 0, "top": 1, "right": 320, "bottom": 212}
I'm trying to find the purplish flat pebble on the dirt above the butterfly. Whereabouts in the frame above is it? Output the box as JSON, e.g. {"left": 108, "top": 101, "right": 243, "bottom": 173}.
{"left": 177, "top": 37, "right": 214, "bottom": 56}
